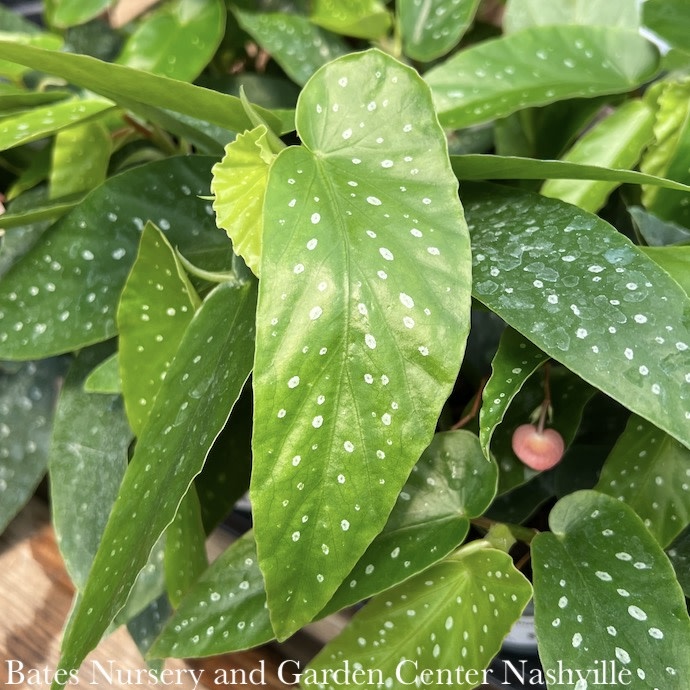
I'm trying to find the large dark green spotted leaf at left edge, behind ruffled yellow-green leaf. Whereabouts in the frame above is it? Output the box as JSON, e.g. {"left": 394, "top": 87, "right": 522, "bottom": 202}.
{"left": 0, "top": 156, "right": 230, "bottom": 359}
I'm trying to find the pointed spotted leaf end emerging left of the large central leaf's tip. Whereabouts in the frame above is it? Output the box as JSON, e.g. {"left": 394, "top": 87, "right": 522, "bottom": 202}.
{"left": 149, "top": 532, "right": 275, "bottom": 658}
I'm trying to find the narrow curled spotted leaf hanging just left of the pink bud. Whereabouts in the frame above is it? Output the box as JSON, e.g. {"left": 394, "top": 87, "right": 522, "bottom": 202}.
{"left": 479, "top": 328, "right": 549, "bottom": 458}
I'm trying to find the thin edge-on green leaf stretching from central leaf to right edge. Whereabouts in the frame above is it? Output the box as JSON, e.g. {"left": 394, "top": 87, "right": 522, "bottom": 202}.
{"left": 450, "top": 153, "right": 690, "bottom": 192}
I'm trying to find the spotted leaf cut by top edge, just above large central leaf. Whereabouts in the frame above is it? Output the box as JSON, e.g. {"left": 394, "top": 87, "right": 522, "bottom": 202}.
{"left": 398, "top": 0, "right": 479, "bottom": 62}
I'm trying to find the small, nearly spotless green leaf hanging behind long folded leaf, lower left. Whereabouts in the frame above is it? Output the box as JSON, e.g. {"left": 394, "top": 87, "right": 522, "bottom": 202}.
{"left": 165, "top": 486, "right": 208, "bottom": 607}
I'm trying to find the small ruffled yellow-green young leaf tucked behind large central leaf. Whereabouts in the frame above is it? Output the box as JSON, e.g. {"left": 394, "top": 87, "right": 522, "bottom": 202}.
{"left": 211, "top": 125, "right": 275, "bottom": 276}
